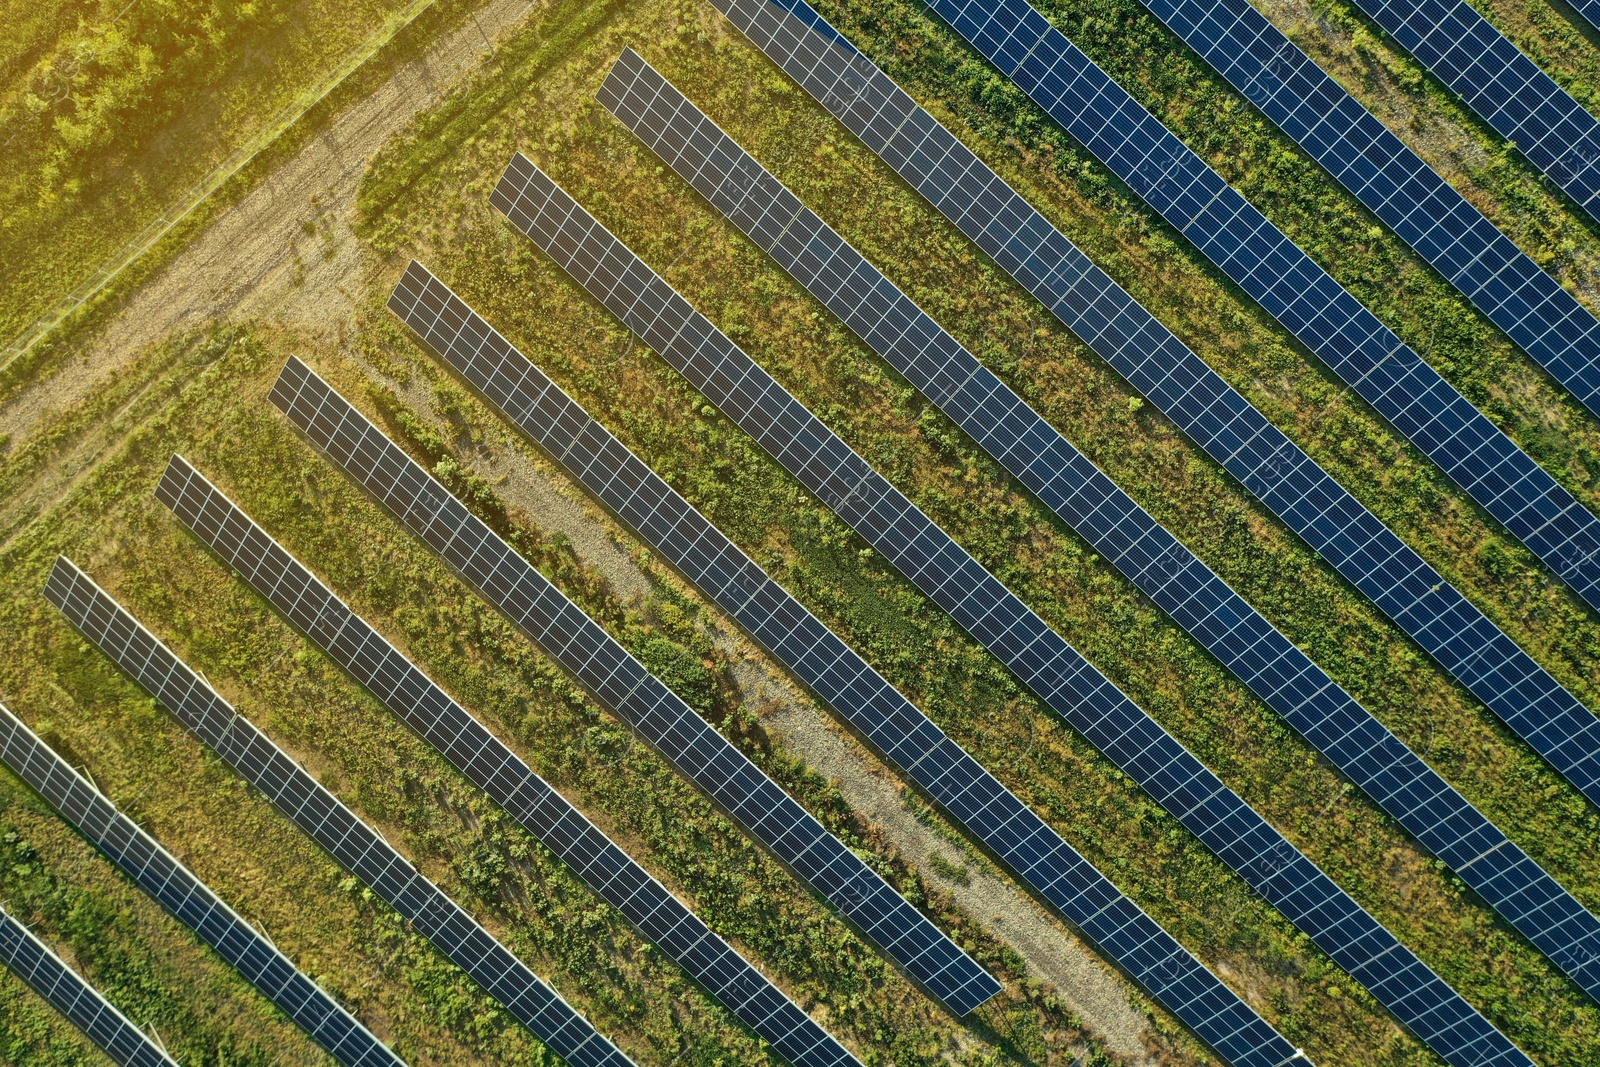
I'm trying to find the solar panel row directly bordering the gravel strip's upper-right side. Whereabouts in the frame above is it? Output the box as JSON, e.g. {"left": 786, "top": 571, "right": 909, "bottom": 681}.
{"left": 389, "top": 262, "right": 1296, "bottom": 1067}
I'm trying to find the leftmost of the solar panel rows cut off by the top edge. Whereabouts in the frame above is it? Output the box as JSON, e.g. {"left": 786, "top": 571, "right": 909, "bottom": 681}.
{"left": 714, "top": 0, "right": 1600, "bottom": 902}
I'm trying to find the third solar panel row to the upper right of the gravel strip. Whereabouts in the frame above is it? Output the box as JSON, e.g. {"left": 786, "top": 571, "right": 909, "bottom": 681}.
{"left": 598, "top": 50, "right": 1600, "bottom": 997}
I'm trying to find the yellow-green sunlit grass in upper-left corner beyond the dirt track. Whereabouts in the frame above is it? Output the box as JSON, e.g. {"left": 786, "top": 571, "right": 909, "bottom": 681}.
{"left": 0, "top": 0, "right": 428, "bottom": 341}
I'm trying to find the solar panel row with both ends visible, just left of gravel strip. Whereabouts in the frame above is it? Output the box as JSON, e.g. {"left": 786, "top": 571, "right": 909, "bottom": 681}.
{"left": 270, "top": 360, "right": 1000, "bottom": 1014}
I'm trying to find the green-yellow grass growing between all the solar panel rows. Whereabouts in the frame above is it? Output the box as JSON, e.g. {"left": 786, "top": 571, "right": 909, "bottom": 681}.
{"left": 9, "top": 0, "right": 1600, "bottom": 1065}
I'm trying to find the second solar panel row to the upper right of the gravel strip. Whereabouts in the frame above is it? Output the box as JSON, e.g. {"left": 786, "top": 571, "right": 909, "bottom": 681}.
{"left": 490, "top": 155, "right": 1531, "bottom": 1067}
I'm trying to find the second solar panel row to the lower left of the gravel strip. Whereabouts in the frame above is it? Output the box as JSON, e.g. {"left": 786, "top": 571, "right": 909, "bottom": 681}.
{"left": 148, "top": 454, "right": 861, "bottom": 1067}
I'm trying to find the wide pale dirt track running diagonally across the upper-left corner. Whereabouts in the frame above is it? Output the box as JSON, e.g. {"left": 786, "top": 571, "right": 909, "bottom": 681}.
{"left": 0, "top": 0, "right": 536, "bottom": 443}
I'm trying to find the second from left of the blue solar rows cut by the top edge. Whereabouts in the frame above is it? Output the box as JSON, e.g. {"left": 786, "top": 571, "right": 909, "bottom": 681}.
{"left": 864, "top": 0, "right": 1600, "bottom": 608}
